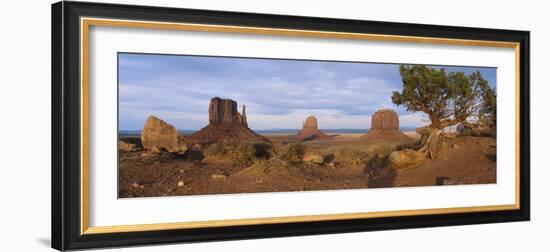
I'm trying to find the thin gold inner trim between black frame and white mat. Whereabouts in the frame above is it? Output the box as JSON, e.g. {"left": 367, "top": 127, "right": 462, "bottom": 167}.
{"left": 80, "top": 18, "right": 520, "bottom": 235}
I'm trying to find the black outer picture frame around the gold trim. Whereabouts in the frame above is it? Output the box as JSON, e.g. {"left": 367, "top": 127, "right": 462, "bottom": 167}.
{"left": 51, "top": 1, "right": 530, "bottom": 250}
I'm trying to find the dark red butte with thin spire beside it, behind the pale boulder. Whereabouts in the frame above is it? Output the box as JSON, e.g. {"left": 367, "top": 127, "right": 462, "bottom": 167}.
{"left": 189, "top": 97, "right": 269, "bottom": 143}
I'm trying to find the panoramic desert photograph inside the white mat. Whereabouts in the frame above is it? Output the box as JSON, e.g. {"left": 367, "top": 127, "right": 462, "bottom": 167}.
{"left": 118, "top": 53, "right": 497, "bottom": 198}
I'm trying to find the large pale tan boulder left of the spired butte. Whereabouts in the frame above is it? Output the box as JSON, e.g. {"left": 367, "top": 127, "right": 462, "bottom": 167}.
{"left": 141, "top": 116, "right": 187, "bottom": 153}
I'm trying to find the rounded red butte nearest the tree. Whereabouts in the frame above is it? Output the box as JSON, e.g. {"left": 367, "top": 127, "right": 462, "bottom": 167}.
{"left": 362, "top": 109, "right": 412, "bottom": 143}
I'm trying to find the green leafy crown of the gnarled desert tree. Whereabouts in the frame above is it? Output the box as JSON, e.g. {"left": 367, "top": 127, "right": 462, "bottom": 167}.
{"left": 392, "top": 65, "right": 496, "bottom": 128}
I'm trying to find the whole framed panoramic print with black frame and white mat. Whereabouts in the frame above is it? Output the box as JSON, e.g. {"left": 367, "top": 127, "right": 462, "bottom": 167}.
{"left": 52, "top": 2, "right": 530, "bottom": 250}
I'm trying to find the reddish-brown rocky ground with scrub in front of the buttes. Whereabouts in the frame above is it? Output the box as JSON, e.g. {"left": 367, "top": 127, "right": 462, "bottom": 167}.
{"left": 118, "top": 134, "right": 496, "bottom": 198}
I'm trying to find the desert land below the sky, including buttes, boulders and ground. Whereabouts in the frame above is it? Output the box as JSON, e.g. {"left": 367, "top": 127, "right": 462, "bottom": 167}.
{"left": 118, "top": 97, "right": 496, "bottom": 198}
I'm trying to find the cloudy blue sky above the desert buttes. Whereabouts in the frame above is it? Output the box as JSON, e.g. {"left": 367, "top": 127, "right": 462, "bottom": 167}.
{"left": 119, "top": 53, "right": 496, "bottom": 130}
